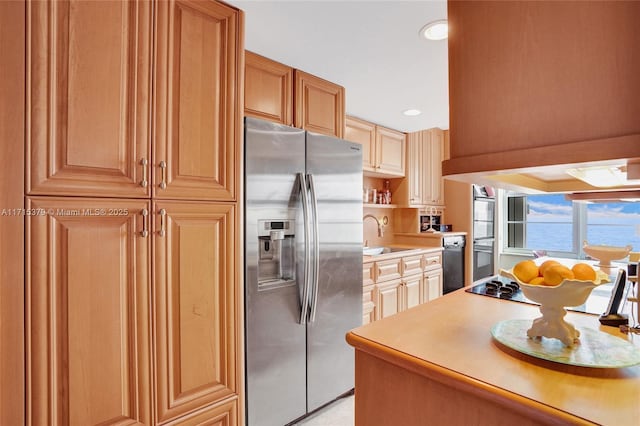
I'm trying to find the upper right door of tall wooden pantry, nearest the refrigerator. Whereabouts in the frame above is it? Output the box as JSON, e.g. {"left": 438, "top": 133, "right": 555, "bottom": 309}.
{"left": 153, "top": 0, "right": 243, "bottom": 201}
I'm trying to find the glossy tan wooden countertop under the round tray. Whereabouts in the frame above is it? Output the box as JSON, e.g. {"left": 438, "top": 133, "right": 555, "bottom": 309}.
{"left": 347, "top": 289, "right": 640, "bottom": 425}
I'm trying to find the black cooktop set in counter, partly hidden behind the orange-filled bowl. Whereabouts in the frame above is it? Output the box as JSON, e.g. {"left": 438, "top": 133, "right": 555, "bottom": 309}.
{"left": 465, "top": 275, "right": 610, "bottom": 315}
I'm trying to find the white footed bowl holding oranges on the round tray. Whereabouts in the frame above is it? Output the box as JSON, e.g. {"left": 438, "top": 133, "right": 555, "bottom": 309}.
{"left": 500, "top": 269, "right": 609, "bottom": 346}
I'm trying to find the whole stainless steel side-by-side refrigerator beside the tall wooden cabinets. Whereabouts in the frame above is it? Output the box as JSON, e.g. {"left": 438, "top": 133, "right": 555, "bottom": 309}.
{"left": 245, "top": 118, "right": 362, "bottom": 426}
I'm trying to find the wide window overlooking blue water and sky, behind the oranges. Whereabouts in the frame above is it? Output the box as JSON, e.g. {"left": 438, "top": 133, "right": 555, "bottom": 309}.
{"left": 503, "top": 193, "right": 640, "bottom": 258}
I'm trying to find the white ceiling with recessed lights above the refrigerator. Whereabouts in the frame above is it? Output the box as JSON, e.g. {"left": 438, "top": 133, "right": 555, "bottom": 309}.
{"left": 227, "top": 0, "right": 449, "bottom": 132}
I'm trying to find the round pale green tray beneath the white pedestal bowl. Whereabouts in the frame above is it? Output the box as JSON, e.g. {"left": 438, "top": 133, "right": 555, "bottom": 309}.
{"left": 491, "top": 319, "right": 640, "bottom": 368}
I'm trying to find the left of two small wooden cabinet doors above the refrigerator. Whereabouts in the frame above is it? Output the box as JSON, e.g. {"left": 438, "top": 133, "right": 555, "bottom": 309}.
{"left": 244, "top": 51, "right": 293, "bottom": 126}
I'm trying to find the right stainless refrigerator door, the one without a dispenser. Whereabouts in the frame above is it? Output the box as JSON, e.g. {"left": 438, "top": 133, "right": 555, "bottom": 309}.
{"left": 307, "top": 132, "right": 362, "bottom": 411}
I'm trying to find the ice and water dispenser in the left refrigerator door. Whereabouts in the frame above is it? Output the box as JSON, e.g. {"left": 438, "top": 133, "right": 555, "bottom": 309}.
{"left": 258, "top": 220, "right": 296, "bottom": 290}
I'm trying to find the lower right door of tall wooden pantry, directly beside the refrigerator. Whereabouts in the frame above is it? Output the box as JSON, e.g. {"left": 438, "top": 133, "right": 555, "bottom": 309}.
{"left": 153, "top": 201, "right": 243, "bottom": 424}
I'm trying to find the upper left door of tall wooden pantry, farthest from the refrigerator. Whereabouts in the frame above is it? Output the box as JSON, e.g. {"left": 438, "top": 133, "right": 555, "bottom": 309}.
{"left": 26, "top": 1, "right": 152, "bottom": 197}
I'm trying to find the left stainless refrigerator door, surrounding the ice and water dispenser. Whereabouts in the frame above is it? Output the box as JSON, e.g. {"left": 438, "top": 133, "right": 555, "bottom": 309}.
{"left": 245, "top": 118, "right": 306, "bottom": 426}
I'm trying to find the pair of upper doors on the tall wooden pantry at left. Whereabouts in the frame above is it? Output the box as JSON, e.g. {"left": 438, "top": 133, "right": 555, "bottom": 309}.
{"left": 27, "top": 0, "right": 242, "bottom": 200}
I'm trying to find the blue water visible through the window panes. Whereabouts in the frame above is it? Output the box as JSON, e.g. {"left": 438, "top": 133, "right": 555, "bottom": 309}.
{"left": 527, "top": 222, "right": 640, "bottom": 252}
